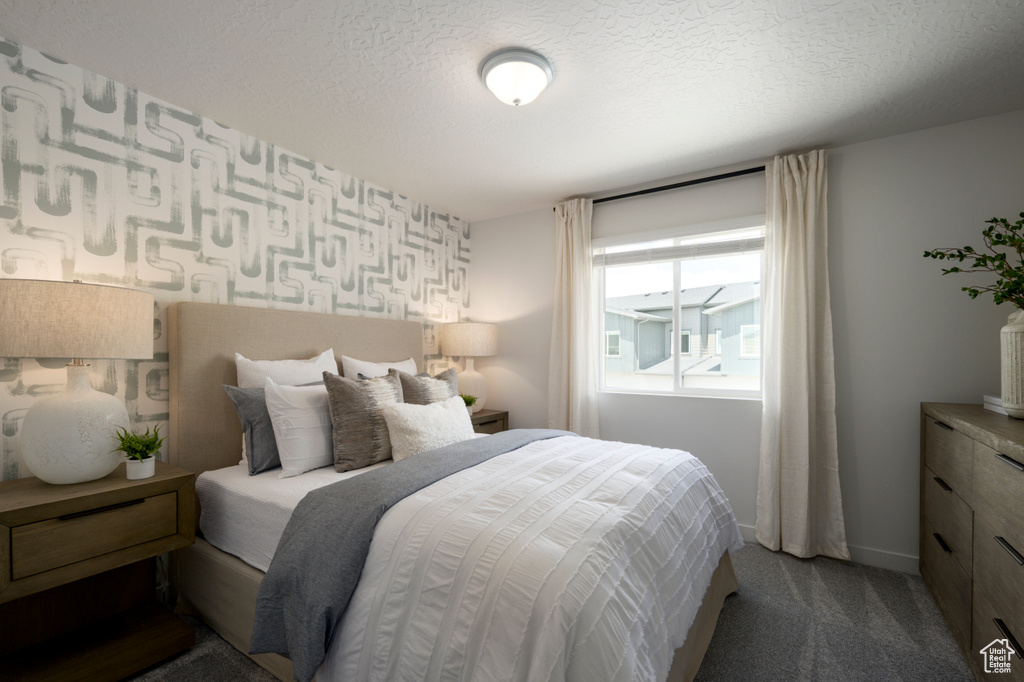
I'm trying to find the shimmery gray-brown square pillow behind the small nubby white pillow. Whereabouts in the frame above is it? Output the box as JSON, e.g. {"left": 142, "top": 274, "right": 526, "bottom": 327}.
{"left": 324, "top": 370, "right": 402, "bottom": 471}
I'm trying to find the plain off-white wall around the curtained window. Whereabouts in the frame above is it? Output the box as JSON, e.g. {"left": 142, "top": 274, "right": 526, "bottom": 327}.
{"left": 472, "top": 107, "right": 1024, "bottom": 571}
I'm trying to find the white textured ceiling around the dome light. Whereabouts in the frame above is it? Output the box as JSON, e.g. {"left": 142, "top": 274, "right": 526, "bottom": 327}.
{"left": 0, "top": 0, "right": 1024, "bottom": 220}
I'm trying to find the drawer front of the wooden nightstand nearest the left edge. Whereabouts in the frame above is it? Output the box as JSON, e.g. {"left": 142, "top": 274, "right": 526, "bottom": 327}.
{"left": 10, "top": 493, "right": 177, "bottom": 581}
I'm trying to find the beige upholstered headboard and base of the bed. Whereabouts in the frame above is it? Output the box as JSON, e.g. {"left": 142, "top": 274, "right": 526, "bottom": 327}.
{"left": 168, "top": 303, "right": 736, "bottom": 681}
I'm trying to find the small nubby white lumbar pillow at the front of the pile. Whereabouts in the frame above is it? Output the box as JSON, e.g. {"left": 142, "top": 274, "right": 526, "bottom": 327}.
{"left": 381, "top": 395, "right": 473, "bottom": 461}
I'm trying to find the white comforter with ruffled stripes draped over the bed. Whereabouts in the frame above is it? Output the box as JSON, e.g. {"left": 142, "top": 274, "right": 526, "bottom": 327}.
{"left": 317, "top": 436, "right": 742, "bottom": 682}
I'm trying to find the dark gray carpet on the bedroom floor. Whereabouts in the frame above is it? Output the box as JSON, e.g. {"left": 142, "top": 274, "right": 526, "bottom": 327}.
{"left": 131, "top": 545, "right": 973, "bottom": 682}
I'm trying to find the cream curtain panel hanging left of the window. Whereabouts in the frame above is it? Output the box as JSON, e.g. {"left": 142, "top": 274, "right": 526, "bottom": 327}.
{"left": 548, "top": 199, "right": 598, "bottom": 438}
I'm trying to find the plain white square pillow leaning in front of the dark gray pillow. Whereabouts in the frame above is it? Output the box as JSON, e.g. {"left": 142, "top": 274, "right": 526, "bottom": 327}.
{"left": 264, "top": 378, "right": 334, "bottom": 478}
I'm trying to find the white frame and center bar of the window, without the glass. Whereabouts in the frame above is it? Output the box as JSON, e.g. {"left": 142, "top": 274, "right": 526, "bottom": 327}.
{"left": 592, "top": 214, "right": 765, "bottom": 400}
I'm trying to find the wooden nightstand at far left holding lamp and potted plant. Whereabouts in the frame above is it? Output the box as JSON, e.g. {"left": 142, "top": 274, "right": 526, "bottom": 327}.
{"left": 0, "top": 462, "right": 196, "bottom": 681}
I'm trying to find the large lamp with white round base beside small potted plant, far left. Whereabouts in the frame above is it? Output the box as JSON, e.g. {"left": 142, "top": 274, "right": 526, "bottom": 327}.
{"left": 0, "top": 279, "right": 153, "bottom": 483}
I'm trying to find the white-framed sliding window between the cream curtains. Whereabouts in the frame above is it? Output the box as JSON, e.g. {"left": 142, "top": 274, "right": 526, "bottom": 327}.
{"left": 594, "top": 223, "right": 764, "bottom": 397}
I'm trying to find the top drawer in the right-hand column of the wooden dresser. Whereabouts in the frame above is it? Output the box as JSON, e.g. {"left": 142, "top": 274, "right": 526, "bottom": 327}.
{"left": 974, "top": 442, "right": 1024, "bottom": 548}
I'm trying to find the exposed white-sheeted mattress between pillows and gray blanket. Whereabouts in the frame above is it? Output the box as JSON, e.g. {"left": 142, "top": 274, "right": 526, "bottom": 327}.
{"left": 196, "top": 460, "right": 390, "bottom": 572}
